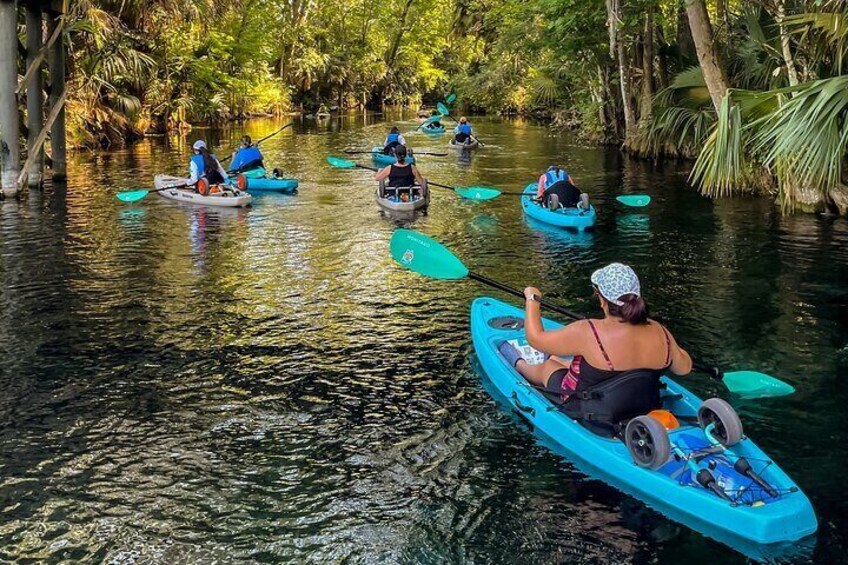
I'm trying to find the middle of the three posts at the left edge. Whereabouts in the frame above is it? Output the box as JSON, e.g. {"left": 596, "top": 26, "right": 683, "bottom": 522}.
{"left": 26, "top": 3, "right": 43, "bottom": 187}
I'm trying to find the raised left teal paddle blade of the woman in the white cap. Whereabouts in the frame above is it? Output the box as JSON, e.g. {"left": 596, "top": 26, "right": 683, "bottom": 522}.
{"left": 389, "top": 229, "right": 468, "bottom": 279}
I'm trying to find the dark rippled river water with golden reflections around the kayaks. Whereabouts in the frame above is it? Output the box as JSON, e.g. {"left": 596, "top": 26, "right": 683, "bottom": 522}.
{"left": 0, "top": 112, "right": 848, "bottom": 563}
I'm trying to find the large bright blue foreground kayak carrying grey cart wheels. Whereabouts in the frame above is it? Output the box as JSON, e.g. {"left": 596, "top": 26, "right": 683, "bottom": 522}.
{"left": 471, "top": 297, "right": 818, "bottom": 547}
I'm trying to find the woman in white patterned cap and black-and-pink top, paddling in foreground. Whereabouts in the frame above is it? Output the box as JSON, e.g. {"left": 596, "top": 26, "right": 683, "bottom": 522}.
{"left": 499, "top": 263, "right": 692, "bottom": 413}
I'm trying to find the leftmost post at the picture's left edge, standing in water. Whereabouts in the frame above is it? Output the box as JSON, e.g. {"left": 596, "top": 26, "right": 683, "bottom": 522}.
{"left": 0, "top": 0, "right": 21, "bottom": 196}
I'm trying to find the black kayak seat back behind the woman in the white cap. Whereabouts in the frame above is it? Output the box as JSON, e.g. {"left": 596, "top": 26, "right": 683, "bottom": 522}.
{"left": 559, "top": 369, "right": 664, "bottom": 437}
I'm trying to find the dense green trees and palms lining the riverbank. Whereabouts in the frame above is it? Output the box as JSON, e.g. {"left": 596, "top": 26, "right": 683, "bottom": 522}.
{"left": 41, "top": 0, "right": 848, "bottom": 213}
